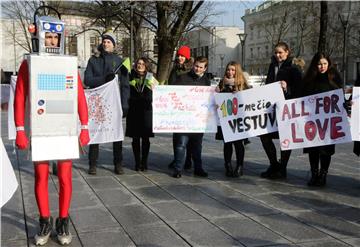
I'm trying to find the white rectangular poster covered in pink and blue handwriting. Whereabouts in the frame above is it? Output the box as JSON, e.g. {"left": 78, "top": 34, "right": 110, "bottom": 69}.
{"left": 153, "top": 86, "right": 217, "bottom": 133}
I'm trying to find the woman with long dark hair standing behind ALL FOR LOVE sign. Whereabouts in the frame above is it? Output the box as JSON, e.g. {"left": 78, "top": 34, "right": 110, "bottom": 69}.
{"left": 304, "top": 53, "right": 342, "bottom": 186}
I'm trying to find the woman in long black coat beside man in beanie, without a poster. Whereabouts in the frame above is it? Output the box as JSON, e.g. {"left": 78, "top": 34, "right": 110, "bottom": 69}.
{"left": 125, "top": 57, "right": 157, "bottom": 171}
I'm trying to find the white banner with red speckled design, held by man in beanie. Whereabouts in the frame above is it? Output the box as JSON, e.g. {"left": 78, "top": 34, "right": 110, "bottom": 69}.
{"left": 85, "top": 76, "right": 124, "bottom": 144}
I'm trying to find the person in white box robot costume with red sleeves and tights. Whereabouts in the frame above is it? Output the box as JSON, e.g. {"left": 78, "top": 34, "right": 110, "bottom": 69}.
{"left": 14, "top": 6, "right": 89, "bottom": 245}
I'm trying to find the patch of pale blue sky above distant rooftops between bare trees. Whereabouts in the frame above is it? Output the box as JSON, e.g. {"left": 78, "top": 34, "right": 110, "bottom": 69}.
{"left": 212, "top": 0, "right": 263, "bottom": 27}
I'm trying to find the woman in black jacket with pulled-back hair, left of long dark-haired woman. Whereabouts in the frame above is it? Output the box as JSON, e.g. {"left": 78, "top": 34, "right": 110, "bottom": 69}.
{"left": 260, "top": 42, "right": 302, "bottom": 179}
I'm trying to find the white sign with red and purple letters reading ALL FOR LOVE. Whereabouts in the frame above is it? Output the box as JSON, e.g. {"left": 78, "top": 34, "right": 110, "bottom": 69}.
{"left": 276, "top": 89, "right": 351, "bottom": 150}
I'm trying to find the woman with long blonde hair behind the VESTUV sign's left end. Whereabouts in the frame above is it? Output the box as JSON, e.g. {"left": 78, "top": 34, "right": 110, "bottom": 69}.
{"left": 215, "top": 61, "right": 249, "bottom": 177}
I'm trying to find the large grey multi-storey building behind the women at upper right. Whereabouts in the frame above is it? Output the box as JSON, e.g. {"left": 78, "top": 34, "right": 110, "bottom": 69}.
{"left": 242, "top": 0, "right": 360, "bottom": 83}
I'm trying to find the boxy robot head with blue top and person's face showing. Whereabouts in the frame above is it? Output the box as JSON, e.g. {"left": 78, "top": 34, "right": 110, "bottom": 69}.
{"left": 29, "top": 6, "right": 65, "bottom": 55}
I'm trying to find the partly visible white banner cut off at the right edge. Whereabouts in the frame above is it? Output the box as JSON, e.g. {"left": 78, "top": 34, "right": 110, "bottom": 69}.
{"left": 350, "top": 87, "right": 360, "bottom": 141}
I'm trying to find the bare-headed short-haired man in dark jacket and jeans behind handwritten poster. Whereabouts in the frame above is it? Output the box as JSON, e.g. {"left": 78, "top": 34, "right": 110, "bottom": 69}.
{"left": 172, "top": 56, "right": 210, "bottom": 178}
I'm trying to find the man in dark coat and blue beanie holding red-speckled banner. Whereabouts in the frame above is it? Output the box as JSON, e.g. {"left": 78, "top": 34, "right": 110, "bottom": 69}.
{"left": 84, "top": 32, "right": 130, "bottom": 175}
